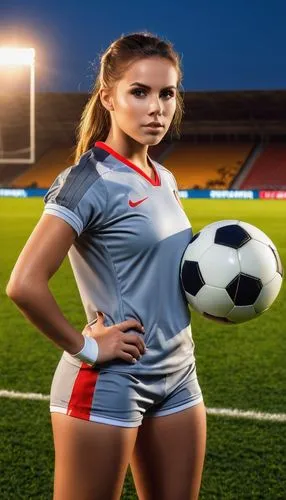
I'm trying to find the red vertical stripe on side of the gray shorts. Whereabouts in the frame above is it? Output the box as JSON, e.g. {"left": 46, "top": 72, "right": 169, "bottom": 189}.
{"left": 67, "top": 363, "right": 99, "bottom": 420}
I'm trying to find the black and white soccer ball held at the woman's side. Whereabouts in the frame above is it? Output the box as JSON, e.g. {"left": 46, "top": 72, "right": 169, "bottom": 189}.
{"left": 180, "top": 220, "right": 283, "bottom": 323}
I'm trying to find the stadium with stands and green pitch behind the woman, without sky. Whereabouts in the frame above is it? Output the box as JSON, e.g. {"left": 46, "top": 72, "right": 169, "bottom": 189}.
{"left": 0, "top": 52, "right": 286, "bottom": 494}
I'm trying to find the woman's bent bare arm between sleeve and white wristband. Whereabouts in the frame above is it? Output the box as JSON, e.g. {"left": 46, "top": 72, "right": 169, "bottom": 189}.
{"left": 6, "top": 214, "right": 84, "bottom": 354}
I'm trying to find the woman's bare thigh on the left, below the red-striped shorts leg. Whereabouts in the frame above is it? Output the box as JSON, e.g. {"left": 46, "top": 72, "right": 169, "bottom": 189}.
{"left": 51, "top": 413, "right": 138, "bottom": 500}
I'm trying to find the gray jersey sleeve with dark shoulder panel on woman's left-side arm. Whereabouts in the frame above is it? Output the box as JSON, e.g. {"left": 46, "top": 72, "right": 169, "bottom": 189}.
{"left": 44, "top": 151, "right": 107, "bottom": 236}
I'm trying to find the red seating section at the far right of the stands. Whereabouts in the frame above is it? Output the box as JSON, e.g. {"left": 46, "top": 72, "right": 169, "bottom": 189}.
{"left": 240, "top": 144, "right": 286, "bottom": 190}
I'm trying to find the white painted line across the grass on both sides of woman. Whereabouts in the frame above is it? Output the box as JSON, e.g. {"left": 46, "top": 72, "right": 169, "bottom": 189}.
{"left": 0, "top": 390, "right": 286, "bottom": 422}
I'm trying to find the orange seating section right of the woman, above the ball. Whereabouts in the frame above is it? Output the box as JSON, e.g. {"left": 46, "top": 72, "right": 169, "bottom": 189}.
{"left": 164, "top": 142, "right": 252, "bottom": 189}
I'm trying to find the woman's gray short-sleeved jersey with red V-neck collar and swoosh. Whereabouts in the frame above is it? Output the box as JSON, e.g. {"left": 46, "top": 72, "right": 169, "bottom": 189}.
{"left": 44, "top": 142, "right": 194, "bottom": 374}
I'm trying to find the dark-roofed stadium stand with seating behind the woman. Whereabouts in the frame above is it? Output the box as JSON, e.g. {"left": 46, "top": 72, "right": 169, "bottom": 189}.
{"left": 0, "top": 90, "right": 286, "bottom": 189}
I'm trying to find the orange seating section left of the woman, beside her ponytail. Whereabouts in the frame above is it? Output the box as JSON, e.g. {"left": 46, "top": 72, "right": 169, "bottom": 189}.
{"left": 12, "top": 147, "right": 74, "bottom": 188}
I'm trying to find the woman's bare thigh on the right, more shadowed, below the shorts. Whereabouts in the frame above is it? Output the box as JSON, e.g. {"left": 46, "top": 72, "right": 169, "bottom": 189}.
{"left": 131, "top": 402, "right": 206, "bottom": 500}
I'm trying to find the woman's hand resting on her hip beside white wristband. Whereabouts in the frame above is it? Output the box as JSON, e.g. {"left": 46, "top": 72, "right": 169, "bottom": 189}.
{"left": 82, "top": 311, "right": 146, "bottom": 364}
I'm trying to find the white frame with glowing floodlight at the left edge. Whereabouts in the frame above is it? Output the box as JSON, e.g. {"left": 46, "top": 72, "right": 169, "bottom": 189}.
{"left": 0, "top": 47, "right": 36, "bottom": 163}
